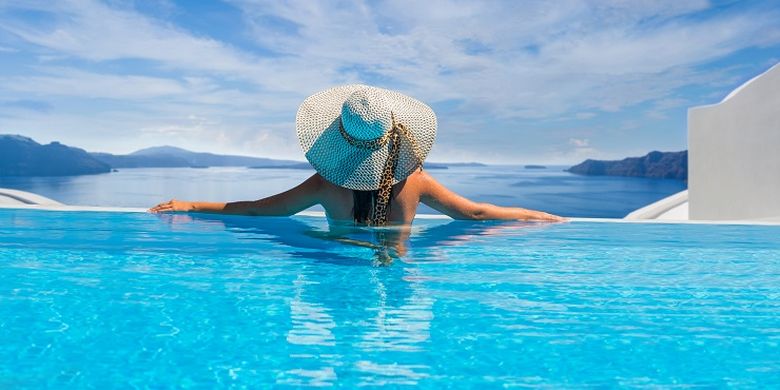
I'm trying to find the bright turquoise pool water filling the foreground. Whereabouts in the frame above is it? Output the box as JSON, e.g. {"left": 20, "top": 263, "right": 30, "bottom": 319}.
{"left": 0, "top": 210, "right": 780, "bottom": 388}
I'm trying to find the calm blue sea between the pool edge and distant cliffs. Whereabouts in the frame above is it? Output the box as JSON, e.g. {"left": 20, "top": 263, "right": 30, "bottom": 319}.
{"left": 0, "top": 165, "right": 686, "bottom": 218}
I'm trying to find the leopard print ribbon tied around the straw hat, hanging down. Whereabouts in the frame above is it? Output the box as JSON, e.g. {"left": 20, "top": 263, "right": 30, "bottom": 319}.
{"left": 339, "top": 114, "right": 423, "bottom": 226}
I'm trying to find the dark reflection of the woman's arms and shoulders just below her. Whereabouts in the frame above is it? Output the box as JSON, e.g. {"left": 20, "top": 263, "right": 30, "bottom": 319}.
{"left": 161, "top": 213, "right": 553, "bottom": 266}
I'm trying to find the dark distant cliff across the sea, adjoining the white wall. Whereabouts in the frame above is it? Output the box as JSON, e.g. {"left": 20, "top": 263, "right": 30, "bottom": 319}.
{"left": 566, "top": 150, "right": 688, "bottom": 180}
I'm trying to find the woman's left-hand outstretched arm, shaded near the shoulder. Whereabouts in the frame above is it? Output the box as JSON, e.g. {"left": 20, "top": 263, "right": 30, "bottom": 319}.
{"left": 149, "top": 174, "right": 323, "bottom": 216}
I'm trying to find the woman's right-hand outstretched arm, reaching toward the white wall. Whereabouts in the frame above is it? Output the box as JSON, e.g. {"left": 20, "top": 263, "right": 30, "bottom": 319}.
{"left": 420, "top": 171, "right": 566, "bottom": 221}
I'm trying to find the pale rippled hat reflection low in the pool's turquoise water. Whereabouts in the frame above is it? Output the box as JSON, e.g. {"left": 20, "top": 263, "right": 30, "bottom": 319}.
{"left": 277, "top": 268, "right": 435, "bottom": 386}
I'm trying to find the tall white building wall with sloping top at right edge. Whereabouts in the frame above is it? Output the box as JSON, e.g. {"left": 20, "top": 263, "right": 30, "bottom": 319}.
{"left": 688, "top": 64, "right": 780, "bottom": 220}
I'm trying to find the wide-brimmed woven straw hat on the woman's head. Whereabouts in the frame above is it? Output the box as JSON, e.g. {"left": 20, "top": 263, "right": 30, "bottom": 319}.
{"left": 295, "top": 84, "right": 436, "bottom": 192}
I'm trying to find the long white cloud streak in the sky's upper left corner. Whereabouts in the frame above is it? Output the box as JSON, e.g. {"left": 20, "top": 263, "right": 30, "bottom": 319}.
{"left": 0, "top": 0, "right": 252, "bottom": 72}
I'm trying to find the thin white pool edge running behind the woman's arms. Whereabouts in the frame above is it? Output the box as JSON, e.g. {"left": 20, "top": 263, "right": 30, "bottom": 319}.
{"left": 0, "top": 204, "right": 780, "bottom": 226}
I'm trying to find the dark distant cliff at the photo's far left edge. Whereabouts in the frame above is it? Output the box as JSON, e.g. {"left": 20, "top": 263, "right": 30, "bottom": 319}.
{"left": 0, "top": 134, "right": 111, "bottom": 176}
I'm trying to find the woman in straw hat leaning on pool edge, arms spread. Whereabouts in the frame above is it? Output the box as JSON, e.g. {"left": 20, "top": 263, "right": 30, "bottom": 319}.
{"left": 149, "top": 84, "right": 564, "bottom": 226}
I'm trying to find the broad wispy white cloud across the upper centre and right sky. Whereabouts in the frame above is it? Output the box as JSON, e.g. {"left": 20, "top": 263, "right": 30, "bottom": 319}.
{"left": 227, "top": 1, "right": 778, "bottom": 118}
